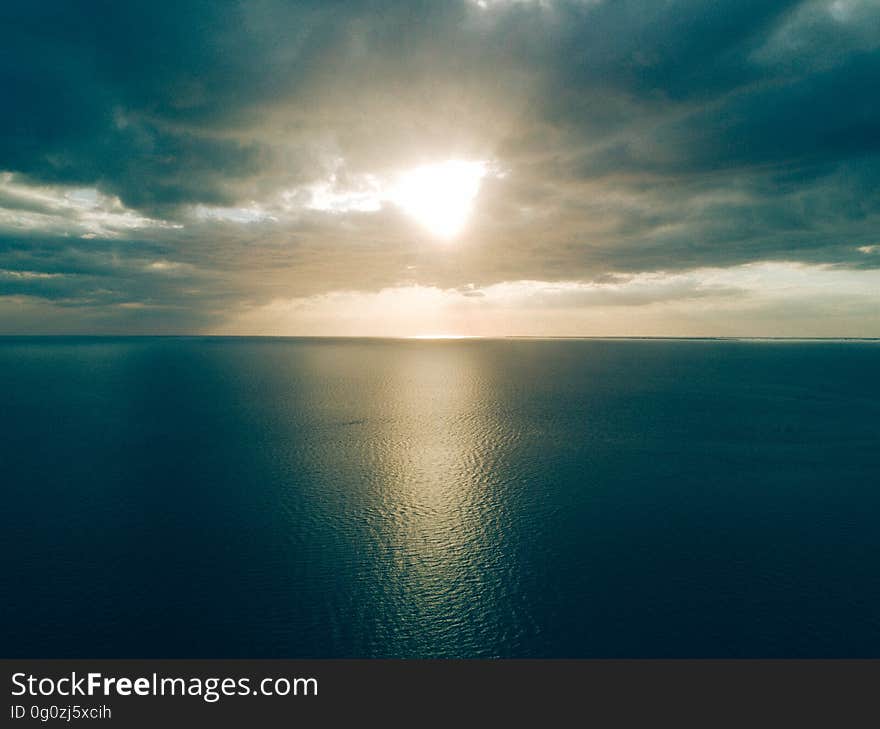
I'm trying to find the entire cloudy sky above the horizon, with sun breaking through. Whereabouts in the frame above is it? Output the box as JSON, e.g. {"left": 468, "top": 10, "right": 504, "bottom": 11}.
{"left": 0, "top": 0, "right": 880, "bottom": 337}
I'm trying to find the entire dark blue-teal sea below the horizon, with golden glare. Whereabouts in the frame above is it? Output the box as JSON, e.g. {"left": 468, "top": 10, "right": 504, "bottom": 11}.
{"left": 0, "top": 339, "right": 880, "bottom": 657}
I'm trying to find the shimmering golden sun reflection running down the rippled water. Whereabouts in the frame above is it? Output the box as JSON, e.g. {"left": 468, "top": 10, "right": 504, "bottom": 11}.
{"left": 370, "top": 345, "right": 524, "bottom": 655}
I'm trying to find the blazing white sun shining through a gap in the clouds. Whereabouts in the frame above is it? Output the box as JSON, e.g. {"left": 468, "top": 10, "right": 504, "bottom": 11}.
{"left": 389, "top": 160, "right": 486, "bottom": 239}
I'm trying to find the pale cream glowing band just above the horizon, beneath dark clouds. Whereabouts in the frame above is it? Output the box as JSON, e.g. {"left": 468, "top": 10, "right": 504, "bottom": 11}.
{"left": 214, "top": 263, "right": 880, "bottom": 337}
